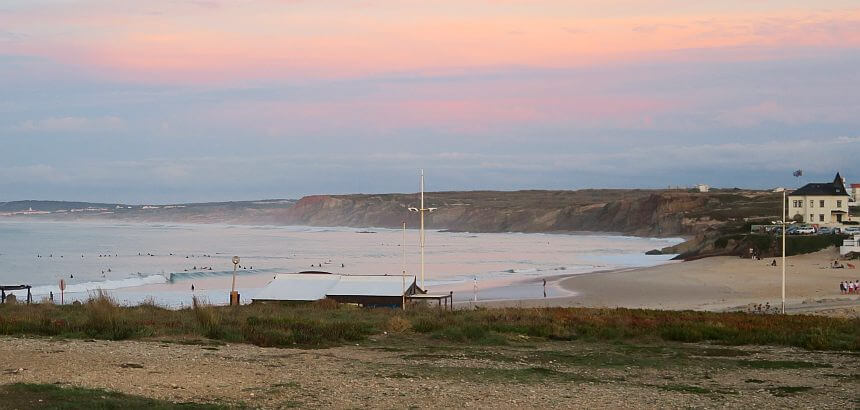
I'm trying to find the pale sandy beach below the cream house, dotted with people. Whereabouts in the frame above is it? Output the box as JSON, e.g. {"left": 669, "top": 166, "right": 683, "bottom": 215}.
{"left": 470, "top": 248, "right": 860, "bottom": 317}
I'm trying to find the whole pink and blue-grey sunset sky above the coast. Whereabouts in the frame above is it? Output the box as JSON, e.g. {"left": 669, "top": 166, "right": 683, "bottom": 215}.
{"left": 0, "top": 0, "right": 860, "bottom": 203}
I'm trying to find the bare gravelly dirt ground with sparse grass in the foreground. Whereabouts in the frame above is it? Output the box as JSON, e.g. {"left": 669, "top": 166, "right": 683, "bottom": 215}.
{"left": 0, "top": 336, "right": 860, "bottom": 409}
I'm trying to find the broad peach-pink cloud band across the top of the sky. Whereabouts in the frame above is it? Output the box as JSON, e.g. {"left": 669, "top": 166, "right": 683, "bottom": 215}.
{"left": 0, "top": 0, "right": 860, "bottom": 83}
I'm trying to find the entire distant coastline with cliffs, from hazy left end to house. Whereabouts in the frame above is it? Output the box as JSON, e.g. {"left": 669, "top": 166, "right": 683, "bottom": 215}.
{"left": 5, "top": 189, "right": 782, "bottom": 257}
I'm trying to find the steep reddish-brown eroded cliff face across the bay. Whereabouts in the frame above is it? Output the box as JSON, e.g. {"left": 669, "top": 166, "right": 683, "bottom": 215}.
{"left": 279, "top": 190, "right": 779, "bottom": 237}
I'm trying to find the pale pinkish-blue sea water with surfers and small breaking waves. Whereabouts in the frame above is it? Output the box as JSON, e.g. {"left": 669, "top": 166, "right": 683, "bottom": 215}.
{"left": 0, "top": 220, "right": 681, "bottom": 306}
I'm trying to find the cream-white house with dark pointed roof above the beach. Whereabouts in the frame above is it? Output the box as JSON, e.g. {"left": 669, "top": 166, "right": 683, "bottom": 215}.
{"left": 788, "top": 173, "right": 851, "bottom": 224}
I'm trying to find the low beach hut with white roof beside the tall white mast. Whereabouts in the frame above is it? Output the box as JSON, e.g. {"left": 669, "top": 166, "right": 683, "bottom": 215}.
{"left": 252, "top": 272, "right": 424, "bottom": 307}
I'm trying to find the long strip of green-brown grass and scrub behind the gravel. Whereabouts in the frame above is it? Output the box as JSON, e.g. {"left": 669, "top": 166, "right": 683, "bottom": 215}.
{"left": 0, "top": 294, "right": 860, "bottom": 350}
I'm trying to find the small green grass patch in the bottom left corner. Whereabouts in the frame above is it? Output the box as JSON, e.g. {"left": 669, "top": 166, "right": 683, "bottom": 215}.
{"left": 0, "top": 383, "right": 230, "bottom": 410}
